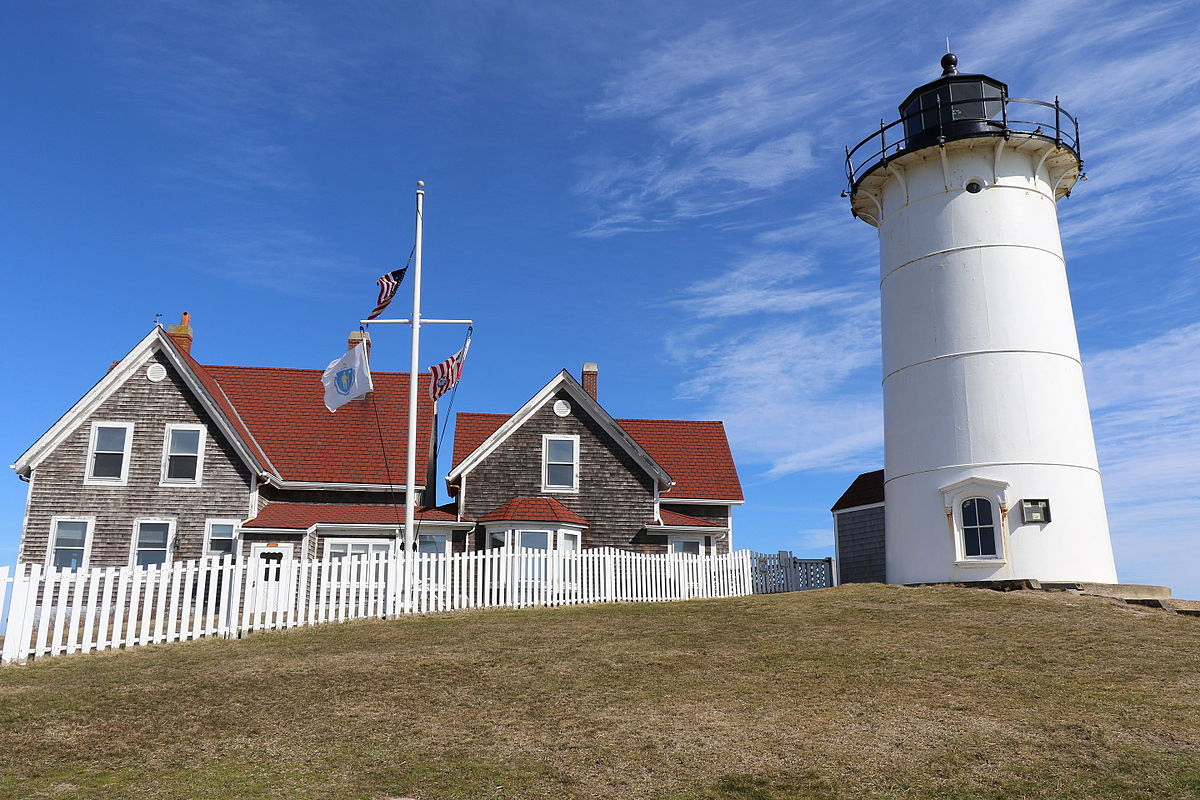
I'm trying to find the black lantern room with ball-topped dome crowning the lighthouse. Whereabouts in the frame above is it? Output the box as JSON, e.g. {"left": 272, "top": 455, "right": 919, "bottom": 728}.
{"left": 900, "top": 53, "right": 1008, "bottom": 149}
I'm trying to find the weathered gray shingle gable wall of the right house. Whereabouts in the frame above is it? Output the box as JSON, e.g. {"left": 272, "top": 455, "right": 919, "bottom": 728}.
{"left": 463, "top": 391, "right": 666, "bottom": 553}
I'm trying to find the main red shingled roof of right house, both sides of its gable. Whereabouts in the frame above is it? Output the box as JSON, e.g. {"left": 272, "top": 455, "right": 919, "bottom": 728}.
{"left": 451, "top": 413, "right": 743, "bottom": 500}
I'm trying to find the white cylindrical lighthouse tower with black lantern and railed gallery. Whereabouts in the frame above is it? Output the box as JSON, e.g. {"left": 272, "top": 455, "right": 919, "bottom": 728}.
{"left": 846, "top": 54, "right": 1117, "bottom": 583}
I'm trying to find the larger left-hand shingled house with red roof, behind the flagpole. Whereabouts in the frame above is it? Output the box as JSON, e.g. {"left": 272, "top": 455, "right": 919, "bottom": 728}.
{"left": 13, "top": 314, "right": 455, "bottom": 567}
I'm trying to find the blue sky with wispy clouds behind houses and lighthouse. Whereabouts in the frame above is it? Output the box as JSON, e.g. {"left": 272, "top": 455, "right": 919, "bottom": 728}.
{"left": 0, "top": 0, "right": 1200, "bottom": 597}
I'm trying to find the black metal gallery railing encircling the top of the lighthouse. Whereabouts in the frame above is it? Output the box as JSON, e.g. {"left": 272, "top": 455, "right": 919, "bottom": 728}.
{"left": 846, "top": 97, "right": 1084, "bottom": 193}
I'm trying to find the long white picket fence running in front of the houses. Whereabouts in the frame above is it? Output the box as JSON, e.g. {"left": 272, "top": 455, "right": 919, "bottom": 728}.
{"left": 0, "top": 548, "right": 832, "bottom": 663}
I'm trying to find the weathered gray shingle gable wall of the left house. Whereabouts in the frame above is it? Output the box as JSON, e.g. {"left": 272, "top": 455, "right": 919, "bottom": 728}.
{"left": 20, "top": 354, "right": 250, "bottom": 566}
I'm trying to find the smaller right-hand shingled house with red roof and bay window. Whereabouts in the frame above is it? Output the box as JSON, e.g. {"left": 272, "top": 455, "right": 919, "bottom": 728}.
{"left": 446, "top": 363, "right": 743, "bottom": 554}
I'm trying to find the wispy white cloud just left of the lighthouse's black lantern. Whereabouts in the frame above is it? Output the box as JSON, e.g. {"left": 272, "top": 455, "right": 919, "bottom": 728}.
{"left": 577, "top": 16, "right": 888, "bottom": 236}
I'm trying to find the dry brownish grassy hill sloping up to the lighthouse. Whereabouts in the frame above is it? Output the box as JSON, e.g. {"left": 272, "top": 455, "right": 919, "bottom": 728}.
{"left": 0, "top": 585, "right": 1200, "bottom": 800}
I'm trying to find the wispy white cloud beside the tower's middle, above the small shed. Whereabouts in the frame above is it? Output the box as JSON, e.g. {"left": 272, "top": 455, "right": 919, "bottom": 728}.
{"left": 668, "top": 252, "right": 882, "bottom": 476}
